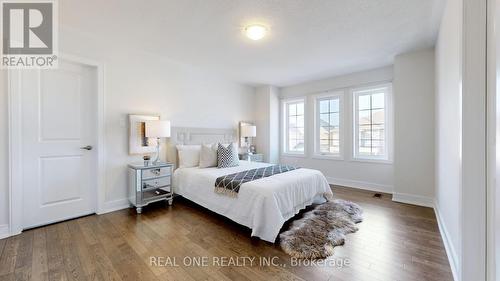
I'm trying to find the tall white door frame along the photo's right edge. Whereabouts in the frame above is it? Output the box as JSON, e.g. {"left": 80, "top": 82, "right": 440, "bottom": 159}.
{"left": 458, "top": 0, "right": 489, "bottom": 281}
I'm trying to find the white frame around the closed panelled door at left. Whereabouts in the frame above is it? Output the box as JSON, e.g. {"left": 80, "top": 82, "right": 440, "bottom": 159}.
{"left": 7, "top": 53, "right": 106, "bottom": 236}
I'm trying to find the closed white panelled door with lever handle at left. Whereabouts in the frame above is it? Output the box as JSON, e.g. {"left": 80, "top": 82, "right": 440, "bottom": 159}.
{"left": 21, "top": 60, "right": 97, "bottom": 229}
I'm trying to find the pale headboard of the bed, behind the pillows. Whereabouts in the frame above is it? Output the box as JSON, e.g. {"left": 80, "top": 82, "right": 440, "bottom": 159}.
{"left": 167, "top": 127, "right": 238, "bottom": 168}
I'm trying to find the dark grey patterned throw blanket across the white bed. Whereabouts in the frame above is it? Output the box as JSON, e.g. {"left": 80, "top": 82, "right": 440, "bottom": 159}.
{"left": 215, "top": 165, "right": 298, "bottom": 196}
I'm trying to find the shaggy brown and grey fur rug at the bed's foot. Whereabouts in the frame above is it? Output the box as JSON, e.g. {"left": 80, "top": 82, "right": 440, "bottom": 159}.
{"left": 280, "top": 199, "right": 363, "bottom": 259}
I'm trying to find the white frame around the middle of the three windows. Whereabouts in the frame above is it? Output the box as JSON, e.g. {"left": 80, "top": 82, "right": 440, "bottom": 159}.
{"left": 313, "top": 91, "right": 345, "bottom": 160}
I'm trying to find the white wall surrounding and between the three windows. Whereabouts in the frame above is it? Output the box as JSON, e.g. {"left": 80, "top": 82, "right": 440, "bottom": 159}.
{"left": 280, "top": 66, "right": 394, "bottom": 193}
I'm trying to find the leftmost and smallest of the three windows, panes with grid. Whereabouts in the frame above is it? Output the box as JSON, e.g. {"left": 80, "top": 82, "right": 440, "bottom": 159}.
{"left": 283, "top": 99, "right": 305, "bottom": 154}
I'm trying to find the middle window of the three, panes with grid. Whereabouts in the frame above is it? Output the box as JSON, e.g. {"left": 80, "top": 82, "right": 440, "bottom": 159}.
{"left": 314, "top": 93, "right": 343, "bottom": 158}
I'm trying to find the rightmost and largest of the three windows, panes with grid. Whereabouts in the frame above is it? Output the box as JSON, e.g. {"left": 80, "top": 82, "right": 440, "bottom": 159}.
{"left": 353, "top": 85, "right": 391, "bottom": 160}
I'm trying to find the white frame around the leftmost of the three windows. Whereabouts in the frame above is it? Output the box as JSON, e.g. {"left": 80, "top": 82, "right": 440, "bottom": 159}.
{"left": 281, "top": 97, "right": 307, "bottom": 157}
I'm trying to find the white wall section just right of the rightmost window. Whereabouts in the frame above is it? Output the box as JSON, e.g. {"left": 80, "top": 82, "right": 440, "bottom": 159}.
{"left": 393, "top": 49, "right": 435, "bottom": 207}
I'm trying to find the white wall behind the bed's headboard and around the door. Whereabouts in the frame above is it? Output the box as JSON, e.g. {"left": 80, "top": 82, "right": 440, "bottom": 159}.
{"left": 0, "top": 26, "right": 255, "bottom": 225}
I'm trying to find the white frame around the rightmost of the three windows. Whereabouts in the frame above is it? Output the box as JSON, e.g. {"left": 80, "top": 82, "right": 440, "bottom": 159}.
{"left": 351, "top": 83, "right": 393, "bottom": 163}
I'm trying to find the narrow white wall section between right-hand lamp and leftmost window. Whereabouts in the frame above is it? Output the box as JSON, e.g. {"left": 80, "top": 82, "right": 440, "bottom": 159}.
{"left": 255, "top": 86, "right": 279, "bottom": 163}
